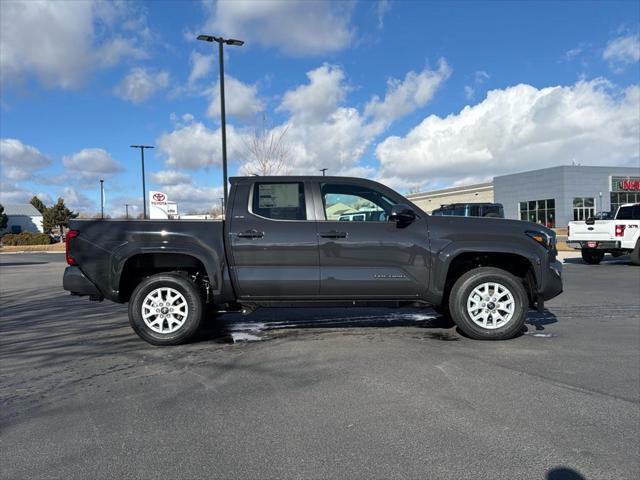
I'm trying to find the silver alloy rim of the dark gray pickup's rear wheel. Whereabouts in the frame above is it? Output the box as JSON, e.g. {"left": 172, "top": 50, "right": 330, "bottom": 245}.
{"left": 142, "top": 287, "right": 189, "bottom": 334}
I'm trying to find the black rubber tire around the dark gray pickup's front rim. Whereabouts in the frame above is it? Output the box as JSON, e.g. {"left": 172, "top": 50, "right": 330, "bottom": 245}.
{"left": 449, "top": 267, "right": 529, "bottom": 340}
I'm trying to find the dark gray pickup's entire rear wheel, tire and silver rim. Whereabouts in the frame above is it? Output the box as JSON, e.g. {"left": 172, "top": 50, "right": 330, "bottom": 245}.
{"left": 129, "top": 273, "right": 204, "bottom": 345}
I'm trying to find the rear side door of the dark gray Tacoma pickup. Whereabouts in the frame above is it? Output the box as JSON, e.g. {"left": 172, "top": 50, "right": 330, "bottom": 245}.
{"left": 229, "top": 182, "right": 320, "bottom": 299}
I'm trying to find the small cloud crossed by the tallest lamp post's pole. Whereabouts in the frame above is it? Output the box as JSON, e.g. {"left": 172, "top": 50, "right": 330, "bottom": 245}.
{"left": 207, "top": 75, "right": 264, "bottom": 120}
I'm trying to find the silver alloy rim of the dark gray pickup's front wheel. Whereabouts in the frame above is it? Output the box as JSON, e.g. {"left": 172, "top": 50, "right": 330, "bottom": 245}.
{"left": 467, "top": 282, "right": 516, "bottom": 330}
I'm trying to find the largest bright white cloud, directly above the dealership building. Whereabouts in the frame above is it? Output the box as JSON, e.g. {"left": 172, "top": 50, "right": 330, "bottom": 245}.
{"left": 376, "top": 80, "right": 640, "bottom": 183}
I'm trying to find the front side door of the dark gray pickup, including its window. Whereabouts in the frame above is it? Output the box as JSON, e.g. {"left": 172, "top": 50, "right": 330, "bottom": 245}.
{"left": 315, "top": 180, "right": 430, "bottom": 299}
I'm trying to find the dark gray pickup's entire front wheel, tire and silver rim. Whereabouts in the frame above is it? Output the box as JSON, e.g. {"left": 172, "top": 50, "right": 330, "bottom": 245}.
{"left": 449, "top": 267, "right": 529, "bottom": 340}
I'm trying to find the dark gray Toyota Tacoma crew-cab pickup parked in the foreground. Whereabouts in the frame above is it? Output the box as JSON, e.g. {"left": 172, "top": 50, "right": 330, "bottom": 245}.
{"left": 63, "top": 177, "right": 562, "bottom": 345}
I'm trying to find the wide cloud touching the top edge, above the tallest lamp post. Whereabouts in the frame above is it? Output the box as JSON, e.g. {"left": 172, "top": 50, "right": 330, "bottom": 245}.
{"left": 203, "top": 0, "right": 354, "bottom": 56}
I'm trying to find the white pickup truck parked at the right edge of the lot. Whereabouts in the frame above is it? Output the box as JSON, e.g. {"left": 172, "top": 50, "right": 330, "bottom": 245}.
{"left": 567, "top": 203, "right": 640, "bottom": 265}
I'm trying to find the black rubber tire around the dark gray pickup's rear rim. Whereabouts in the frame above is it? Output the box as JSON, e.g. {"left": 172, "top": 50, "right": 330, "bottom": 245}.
{"left": 129, "top": 273, "right": 205, "bottom": 345}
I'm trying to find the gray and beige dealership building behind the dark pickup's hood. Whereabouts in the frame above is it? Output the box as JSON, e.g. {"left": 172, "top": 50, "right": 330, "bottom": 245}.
{"left": 407, "top": 165, "right": 640, "bottom": 228}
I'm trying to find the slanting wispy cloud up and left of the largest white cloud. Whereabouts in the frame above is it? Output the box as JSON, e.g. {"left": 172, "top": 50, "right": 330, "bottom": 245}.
{"left": 365, "top": 59, "right": 451, "bottom": 126}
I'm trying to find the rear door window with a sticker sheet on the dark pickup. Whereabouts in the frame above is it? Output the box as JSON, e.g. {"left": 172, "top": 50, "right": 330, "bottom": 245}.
{"left": 251, "top": 182, "right": 307, "bottom": 220}
